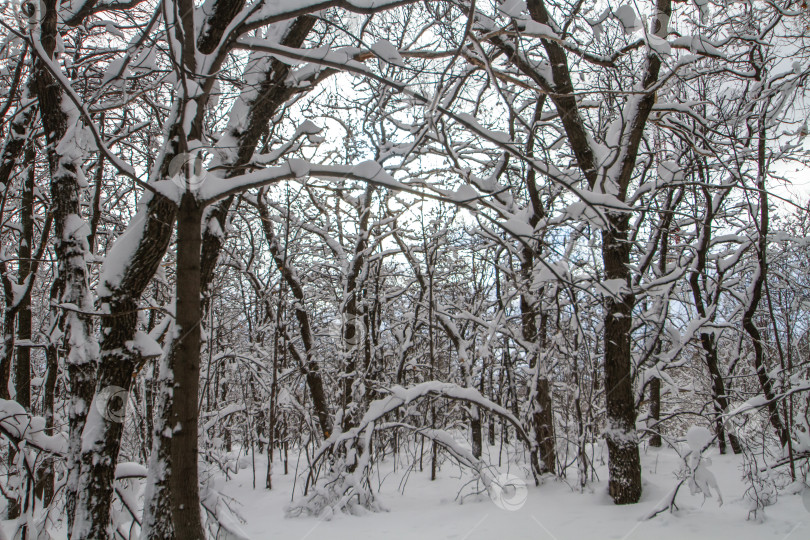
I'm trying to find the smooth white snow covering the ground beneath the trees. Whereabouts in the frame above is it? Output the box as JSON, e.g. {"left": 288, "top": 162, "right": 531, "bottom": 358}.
{"left": 217, "top": 442, "right": 810, "bottom": 540}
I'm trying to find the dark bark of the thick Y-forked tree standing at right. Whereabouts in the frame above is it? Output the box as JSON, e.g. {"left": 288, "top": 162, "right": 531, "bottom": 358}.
{"left": 502, "top": 0, "right": 672, "bottom": 504}
